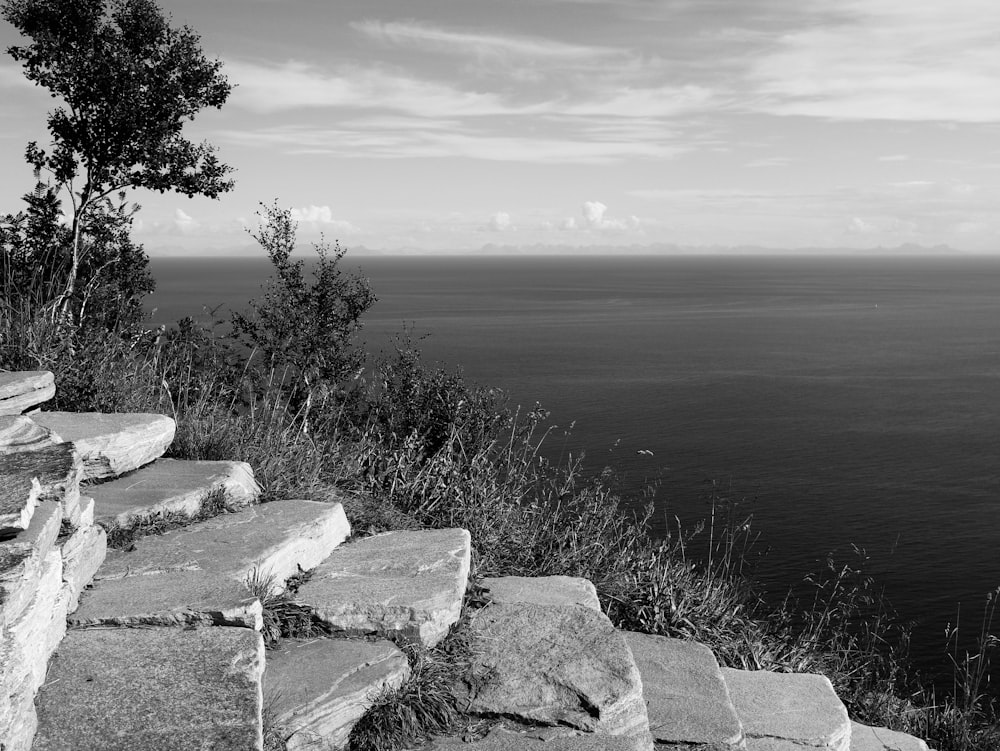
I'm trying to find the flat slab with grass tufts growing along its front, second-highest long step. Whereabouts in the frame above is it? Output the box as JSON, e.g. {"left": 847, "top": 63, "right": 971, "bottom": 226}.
{"left": 87, "top": 459, "right": 260, "bottom": 525}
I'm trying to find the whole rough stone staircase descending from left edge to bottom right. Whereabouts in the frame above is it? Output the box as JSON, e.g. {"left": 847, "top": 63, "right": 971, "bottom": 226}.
{"left": 0, "top": 373, "right": 927, "bottom": 751}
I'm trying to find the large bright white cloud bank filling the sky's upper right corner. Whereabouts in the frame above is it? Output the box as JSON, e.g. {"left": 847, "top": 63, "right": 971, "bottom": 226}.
{"left": 745, "top": 0, "right": 1000, "bottom": 123}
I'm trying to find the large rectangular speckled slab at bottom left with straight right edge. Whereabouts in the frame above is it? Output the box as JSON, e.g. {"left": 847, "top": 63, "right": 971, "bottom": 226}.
{"left": 33, "top": 628, "right": 264, "bottom": 751}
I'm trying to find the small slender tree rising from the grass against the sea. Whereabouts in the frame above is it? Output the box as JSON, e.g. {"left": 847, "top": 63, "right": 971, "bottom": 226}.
{"left": 232, "top": 203, "right": 375, "bottom": 426}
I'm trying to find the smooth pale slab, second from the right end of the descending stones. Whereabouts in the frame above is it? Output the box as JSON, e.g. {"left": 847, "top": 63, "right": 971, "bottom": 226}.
{"left": 722, "top": 668, "right": 851, "bottom": 751}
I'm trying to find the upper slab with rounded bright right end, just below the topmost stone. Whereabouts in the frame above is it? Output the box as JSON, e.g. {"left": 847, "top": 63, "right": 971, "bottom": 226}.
{"left": 31, "top": 412, "right": 176, "bottom": 480}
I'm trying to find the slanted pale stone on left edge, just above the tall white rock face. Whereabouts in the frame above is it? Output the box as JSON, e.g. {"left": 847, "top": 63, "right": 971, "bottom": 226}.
{"left": 0, "top": 501, "right": 62, "bottom": 633}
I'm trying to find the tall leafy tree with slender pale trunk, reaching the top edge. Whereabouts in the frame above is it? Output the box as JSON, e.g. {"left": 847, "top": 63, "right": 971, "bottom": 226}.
{"left": 0, "top": 0, "right": 233, "bottom": 313}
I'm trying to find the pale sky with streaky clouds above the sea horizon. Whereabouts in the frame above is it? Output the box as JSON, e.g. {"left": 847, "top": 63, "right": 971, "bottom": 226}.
{"left": 0, "top": 0, "right": 1000, "bottom": 255}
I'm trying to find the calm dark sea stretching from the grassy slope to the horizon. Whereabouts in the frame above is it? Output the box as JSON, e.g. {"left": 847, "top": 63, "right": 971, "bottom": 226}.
{"left": 151, "top": 257, "right": 1000, "bottom": 680}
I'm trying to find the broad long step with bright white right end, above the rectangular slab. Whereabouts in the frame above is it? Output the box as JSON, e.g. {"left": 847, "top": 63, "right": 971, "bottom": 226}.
{"left": 70, "top": 501, "right": 350, "bottom": 629}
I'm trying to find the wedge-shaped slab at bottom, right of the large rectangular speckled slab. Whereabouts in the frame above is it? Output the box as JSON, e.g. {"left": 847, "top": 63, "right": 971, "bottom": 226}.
{"left": 264, "top": 639, "right": 410, "bottom": 751}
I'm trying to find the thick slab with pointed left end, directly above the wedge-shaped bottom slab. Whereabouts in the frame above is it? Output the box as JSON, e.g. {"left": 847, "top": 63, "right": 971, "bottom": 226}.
{"left": 296, "top": 529, "right": 472, "bottom": 647}
